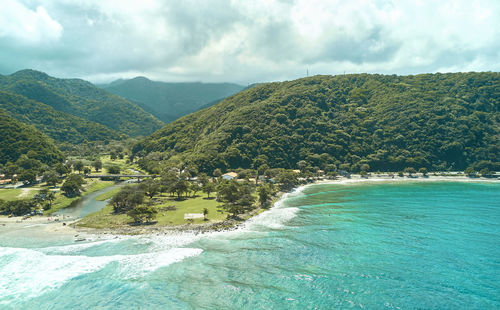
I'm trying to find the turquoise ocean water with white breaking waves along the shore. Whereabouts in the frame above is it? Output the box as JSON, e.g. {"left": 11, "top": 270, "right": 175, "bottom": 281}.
{"left": 0, "top": 182, "right": 500, "bottom": 309}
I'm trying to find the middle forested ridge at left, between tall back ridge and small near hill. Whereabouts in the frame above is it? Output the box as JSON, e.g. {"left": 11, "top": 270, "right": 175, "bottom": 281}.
{"left": 0, "top": 91, "right": 125, "bottom": 144}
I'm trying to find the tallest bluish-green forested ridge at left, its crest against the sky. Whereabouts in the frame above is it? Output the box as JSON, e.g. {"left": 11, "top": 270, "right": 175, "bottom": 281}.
{"left": 0, "top": 70, "right": 162, "bottom": 136}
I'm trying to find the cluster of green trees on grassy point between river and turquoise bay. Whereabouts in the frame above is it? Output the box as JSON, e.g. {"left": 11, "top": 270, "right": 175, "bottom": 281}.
{"left": 110, "top": 168, "right": 299, "bottom": 223}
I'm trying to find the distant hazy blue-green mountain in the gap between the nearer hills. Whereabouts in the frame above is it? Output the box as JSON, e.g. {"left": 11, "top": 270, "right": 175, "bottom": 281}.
{"left": 100, "top": 77, "right": 244, "bottom": 123}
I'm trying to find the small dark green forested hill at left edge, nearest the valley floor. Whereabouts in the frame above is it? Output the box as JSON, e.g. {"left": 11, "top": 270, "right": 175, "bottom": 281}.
{"left": 0, "top": 109, "right": 63, "bottom": 165}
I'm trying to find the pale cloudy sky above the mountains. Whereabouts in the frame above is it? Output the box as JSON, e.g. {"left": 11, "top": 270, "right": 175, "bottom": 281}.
{"left": 0, "top": 0, "right": 500, "bottom": 85}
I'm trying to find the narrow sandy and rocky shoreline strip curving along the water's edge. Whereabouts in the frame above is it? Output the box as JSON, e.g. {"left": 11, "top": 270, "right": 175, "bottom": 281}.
{"left": 0, "top": 174, "right": 500, "bottom": 241}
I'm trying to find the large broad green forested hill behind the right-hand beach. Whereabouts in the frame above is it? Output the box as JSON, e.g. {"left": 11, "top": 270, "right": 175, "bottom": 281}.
{"left": 134, "top": 73, "right": 500, "bottom": 172}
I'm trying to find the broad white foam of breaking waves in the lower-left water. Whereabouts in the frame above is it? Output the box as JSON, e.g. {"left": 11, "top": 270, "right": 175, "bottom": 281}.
{"left": 0, "top": 240, "right": 203, "bottom": 304}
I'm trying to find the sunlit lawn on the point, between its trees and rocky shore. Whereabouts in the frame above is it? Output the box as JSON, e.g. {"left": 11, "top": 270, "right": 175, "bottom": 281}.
{"left": 78, "top": 192, "right": 227, "bottom": 228}
